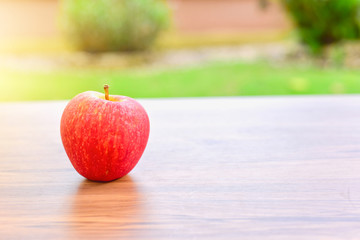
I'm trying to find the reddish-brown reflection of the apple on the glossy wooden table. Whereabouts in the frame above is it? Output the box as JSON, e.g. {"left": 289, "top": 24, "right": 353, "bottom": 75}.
{"left": 68, "top": 175, "right": 144, "bottom": 239}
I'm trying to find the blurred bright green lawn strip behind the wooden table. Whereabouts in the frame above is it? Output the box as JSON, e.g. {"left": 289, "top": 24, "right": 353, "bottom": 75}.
{"left": 0, "top": 62, "right": 360, "bottom": 101}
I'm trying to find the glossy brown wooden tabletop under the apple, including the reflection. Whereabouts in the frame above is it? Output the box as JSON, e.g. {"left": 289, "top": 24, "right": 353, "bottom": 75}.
{"left": 0, "top": 96, "right": 360, "bottom": 240}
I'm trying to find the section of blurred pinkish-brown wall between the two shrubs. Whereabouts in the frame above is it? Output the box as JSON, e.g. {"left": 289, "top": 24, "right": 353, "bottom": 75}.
{"left": 168, "top": 0, "right": 288, "bottom": 32}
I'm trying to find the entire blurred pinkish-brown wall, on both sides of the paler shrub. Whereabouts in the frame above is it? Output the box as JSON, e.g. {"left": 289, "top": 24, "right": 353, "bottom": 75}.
{"left": 0, "top": 0, "right": 288, "bottom": 41}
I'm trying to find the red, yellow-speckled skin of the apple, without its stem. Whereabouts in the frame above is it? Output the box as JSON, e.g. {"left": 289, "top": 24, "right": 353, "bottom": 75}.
{"left": 60, "top": 91, "right": 150, "bottom": 182}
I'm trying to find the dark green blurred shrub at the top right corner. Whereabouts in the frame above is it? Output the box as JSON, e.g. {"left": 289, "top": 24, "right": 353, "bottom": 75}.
{"left": 282, "top": 0, "right": 360, "bottom": 54}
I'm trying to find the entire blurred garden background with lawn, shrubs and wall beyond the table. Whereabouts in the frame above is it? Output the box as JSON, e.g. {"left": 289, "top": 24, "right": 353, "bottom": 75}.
{"left": 0, "top": 0, "right": 360, "bottom": 101}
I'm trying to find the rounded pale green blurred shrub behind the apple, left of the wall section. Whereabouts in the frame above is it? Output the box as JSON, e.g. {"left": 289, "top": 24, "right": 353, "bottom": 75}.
{"left": 60, "top": 0, "right": 169, "bottom": 52}
